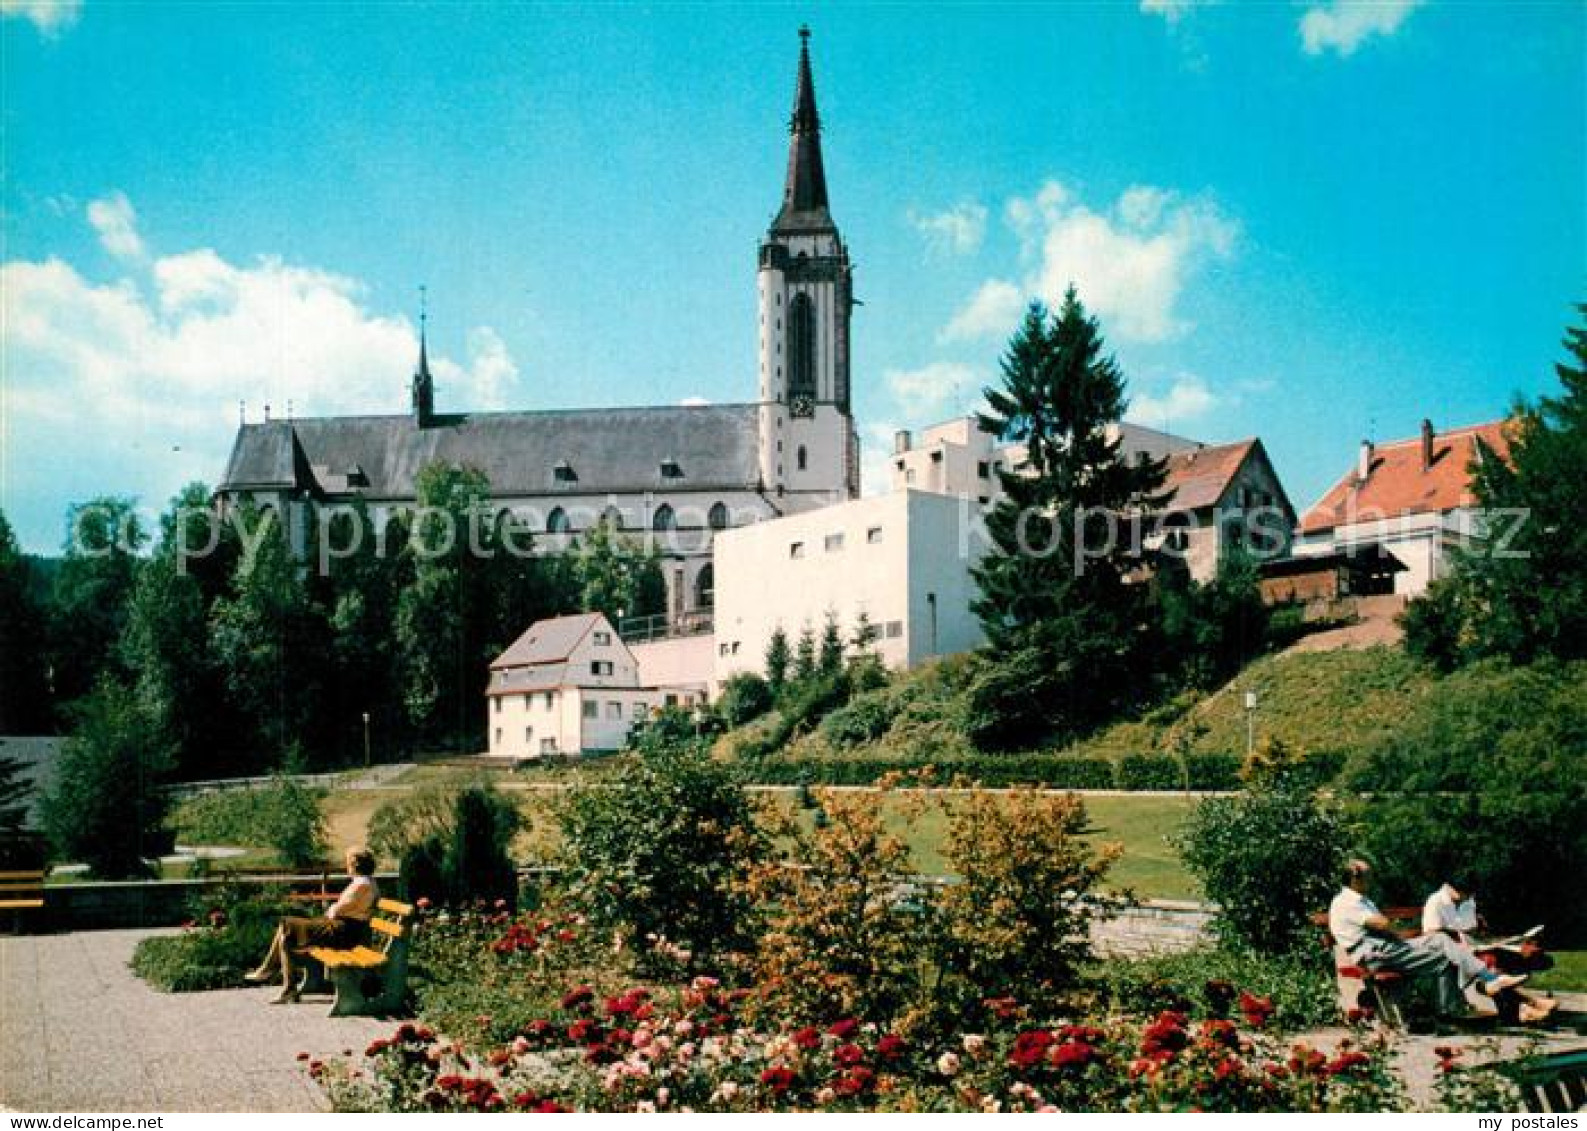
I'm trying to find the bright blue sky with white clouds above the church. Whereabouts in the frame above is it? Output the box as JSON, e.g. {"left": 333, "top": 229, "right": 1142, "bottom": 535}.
{"left": 0, "top": 0, "right": 1587, "bottom": 552}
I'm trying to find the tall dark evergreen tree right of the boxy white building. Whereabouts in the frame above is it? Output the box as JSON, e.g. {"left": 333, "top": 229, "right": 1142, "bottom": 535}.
{"left": 970, "top": 287, "right": 1166, "bottom": 749}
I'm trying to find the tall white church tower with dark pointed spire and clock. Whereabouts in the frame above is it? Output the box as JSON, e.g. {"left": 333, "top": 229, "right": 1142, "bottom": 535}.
{"left": 759, "top": 27, "right": 860, "bottom": 511}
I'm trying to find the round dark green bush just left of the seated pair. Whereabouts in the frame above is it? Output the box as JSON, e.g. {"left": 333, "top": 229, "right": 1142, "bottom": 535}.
{"left": 1176, "top": 782, "right": 1347, "bottom": 953}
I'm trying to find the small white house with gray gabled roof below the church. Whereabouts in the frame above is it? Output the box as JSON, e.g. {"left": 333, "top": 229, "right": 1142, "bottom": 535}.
{"left": 486, "top": 612, "right": 697, "bottom": 758}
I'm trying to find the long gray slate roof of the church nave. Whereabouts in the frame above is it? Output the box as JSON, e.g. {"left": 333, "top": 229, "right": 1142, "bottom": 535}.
{"left": 219, "top": 404, "right": 760, "bottom": 500}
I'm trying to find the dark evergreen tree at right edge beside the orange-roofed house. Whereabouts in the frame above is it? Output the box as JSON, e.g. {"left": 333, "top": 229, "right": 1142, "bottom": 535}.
{"left": 1457, "top": 305, "right": 1587, "bottom": 663}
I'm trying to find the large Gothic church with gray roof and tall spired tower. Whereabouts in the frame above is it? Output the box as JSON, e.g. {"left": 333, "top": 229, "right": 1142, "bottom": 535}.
{"left": 216, "top": 29, "right": 860, "bottom": 627}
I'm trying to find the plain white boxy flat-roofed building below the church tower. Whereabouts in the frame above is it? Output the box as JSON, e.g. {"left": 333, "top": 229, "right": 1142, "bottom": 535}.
{"left": 716, "top": 490, "right": 987, "bottom": 688}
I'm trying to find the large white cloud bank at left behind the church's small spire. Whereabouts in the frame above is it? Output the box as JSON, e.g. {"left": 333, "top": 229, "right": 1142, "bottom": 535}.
{"left": 0, "top": 201, "right": 521, "bottom": 539}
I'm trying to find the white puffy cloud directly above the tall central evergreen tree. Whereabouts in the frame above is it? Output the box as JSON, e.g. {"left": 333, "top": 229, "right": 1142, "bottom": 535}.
{"left": 943, "top": 181, "right": 1239, "bottom": 341}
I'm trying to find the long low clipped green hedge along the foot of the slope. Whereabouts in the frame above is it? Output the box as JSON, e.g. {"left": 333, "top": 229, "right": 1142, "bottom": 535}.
{"left": 746, "top": 753, "right": 1241, "bottom": 792}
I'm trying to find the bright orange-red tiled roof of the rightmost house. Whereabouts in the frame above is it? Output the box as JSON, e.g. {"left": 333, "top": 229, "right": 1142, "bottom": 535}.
{"left": 1300, "top": 420, "right": 1509, "bottom": 533}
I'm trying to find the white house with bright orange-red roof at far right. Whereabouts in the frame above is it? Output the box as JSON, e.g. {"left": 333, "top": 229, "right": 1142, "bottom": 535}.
{"left": 1295, "top": 420, "right": 1509, "bottom": 596}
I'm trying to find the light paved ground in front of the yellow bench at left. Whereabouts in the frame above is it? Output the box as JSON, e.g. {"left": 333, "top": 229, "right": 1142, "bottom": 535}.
{"left": 0, "top": 931, "right": 394, "bottom": 1112}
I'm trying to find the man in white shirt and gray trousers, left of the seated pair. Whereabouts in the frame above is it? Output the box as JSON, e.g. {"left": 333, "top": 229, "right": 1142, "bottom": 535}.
{"left": 1328, "top": 860, "right": 1527, "bottom": 1014}
